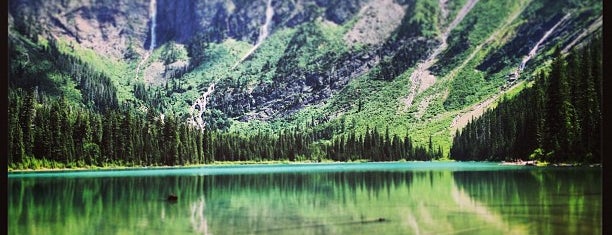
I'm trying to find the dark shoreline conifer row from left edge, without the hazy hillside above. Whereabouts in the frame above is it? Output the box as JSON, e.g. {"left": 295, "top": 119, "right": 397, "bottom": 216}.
{"left": 8, "top": 88, "right": 442, "bottom": 169}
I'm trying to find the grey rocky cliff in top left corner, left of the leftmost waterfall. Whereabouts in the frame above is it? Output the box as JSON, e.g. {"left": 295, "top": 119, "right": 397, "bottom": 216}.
{"left": 9, "top": 0, "right": 149, "bottom": 58}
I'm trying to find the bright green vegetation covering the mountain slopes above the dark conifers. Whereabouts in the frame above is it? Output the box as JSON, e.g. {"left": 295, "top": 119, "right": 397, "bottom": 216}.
{"left": 9, "top": 0, "right": 601, "bottom": 168}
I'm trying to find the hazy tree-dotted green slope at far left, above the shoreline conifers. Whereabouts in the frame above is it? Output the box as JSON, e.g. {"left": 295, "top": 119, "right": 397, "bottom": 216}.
{"left": 9, "top": 32, "right": 119, "bottom": 111}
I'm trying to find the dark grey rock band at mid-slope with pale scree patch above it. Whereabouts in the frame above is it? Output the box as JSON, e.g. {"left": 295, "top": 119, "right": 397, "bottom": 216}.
{"left": 202, "top": 0, "right": 439, "bottom": 121}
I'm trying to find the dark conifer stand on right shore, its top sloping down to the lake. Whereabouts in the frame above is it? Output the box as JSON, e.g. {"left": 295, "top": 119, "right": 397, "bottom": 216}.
{"left": 450, "top": 38, "right": 603, "bottom": 163}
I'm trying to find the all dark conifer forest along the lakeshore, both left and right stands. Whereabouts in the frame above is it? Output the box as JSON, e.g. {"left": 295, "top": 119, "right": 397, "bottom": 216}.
{"left": 8, "top": 34, "right": 603, "bottom": 169}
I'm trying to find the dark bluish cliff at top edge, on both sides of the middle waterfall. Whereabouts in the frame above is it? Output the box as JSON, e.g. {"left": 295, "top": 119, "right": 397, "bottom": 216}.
{"left": 153, "top": 0, "right": 368, "bottom": 44}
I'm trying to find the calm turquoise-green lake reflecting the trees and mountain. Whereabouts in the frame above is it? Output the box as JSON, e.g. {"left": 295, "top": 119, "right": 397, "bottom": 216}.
{"left": 8, "top": 162, "right": 602, "bottom": 235}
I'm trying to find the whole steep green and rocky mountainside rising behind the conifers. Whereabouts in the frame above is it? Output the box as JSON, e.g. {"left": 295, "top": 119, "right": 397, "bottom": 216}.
{"left": 9, "top": 0, "right": 602, "bottom": 162}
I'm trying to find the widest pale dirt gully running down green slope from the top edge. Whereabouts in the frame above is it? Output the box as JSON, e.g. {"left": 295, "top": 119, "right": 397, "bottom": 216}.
{"left": 404, "top": 0, "right": 478, "bottom": 108}
